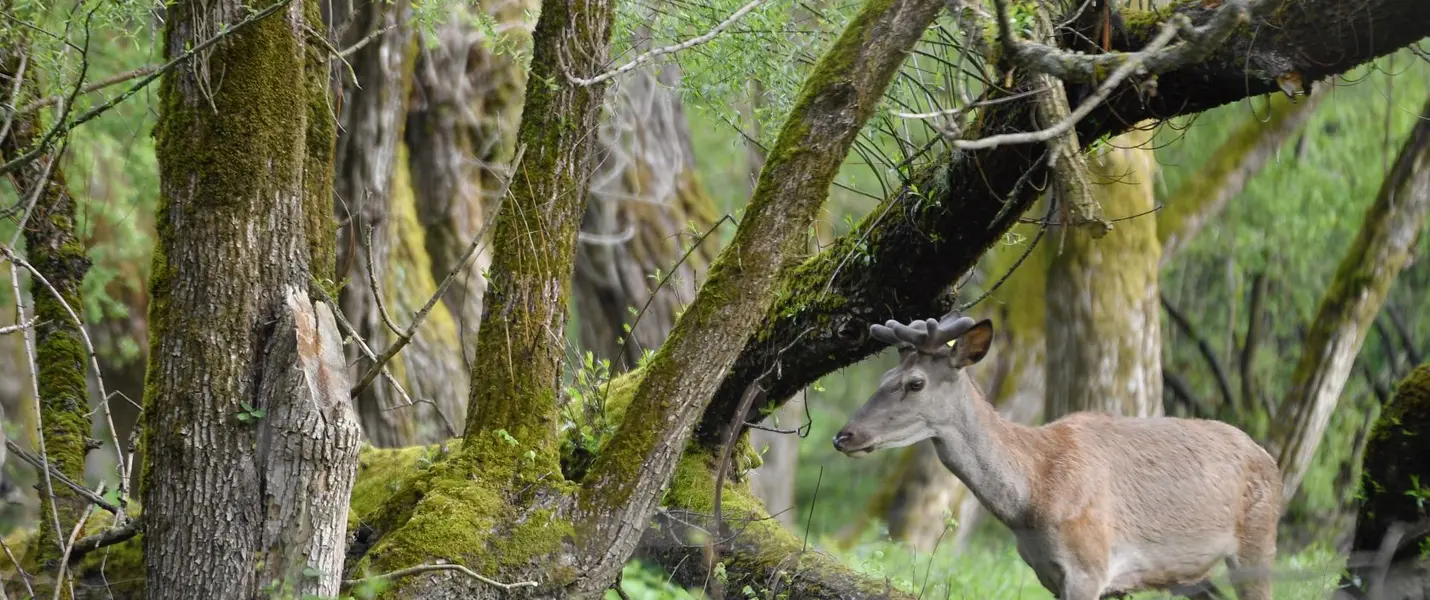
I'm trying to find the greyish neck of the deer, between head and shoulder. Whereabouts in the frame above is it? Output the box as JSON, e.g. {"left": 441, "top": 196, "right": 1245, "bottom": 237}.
{"left": 934, "top": 377, "right": 1031, "bottom": 524}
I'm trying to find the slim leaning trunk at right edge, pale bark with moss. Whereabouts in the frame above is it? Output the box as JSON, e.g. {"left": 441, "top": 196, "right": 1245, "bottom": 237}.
{"left": 1271, "top": 93, "right": 1430, "bottom": 503}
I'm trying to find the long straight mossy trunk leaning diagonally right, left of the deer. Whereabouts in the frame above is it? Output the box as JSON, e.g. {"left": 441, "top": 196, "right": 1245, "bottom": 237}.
{"left": 569, "top": 0, "right": 942, "bottom": 579}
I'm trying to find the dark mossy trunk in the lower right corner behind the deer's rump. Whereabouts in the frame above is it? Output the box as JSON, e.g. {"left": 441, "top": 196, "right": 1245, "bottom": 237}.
{"left": 1336, "top": 364, "right": 1430, "bottom": 600}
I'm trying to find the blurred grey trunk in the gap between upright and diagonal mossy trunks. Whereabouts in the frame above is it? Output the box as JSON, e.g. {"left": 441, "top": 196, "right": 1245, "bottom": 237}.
{"left": 573, "top": 64, "right": 716, "bottom": 373}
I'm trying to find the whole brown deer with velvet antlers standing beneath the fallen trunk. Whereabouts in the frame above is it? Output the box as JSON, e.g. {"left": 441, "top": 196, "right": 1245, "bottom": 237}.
{"left": 834, "top": 316, "right": 1281, "bottom": 600}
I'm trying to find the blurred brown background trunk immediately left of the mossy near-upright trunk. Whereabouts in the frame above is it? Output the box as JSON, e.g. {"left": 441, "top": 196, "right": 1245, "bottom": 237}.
{"left": 405, "top": 0, "right": 536, "bottom": 355}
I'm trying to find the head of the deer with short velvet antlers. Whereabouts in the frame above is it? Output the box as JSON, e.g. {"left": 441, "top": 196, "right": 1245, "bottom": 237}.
{"left": 834, "top": 316, "right": 992, "bottom": 457}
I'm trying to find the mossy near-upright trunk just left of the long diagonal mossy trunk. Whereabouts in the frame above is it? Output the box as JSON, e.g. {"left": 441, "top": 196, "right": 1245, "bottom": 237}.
{"left": 465, "top": 0, "right": 615, "bottom": 462}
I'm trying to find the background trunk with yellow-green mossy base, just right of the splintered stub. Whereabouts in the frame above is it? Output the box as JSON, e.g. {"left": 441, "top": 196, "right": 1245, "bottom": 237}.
{"left": 335, "top": 1, "right": 468, "bottom": 447}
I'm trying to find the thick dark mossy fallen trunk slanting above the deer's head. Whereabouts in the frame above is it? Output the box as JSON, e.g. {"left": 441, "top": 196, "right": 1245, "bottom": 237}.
{"left": 696, "top": 0, "right": 1430, "bottom": 448}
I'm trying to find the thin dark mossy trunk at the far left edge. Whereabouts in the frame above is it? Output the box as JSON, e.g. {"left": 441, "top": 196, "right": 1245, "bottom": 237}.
{"left": 0, "top": 39, "right": 93, "bottom": 594}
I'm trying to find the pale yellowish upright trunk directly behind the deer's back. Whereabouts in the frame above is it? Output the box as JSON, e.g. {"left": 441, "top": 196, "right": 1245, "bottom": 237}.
{"left": 1045, "top": 130, "right": 1163, "bottom": 420}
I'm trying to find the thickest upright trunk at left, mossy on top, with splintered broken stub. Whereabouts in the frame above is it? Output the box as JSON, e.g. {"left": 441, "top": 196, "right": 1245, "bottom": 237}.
{"left": 143, "top": 0, "right": 360, "bottom": 600}
